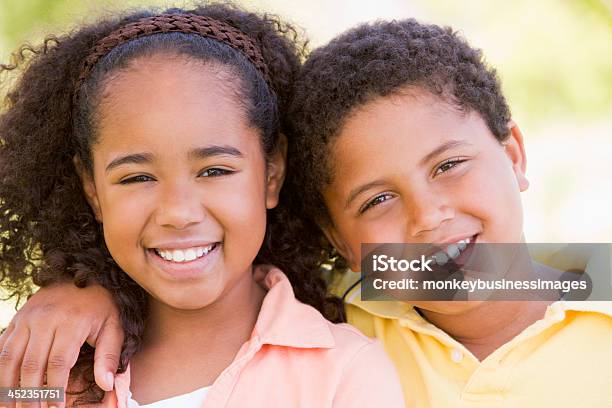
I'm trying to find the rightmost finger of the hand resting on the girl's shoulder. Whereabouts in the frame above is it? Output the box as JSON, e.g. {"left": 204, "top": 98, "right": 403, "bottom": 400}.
{"left": 94, "top": 319, "right": 124, "bottom": 391}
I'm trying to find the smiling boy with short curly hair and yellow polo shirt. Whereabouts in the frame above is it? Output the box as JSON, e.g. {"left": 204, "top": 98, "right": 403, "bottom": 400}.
{"left": 5, "top": 15, "right": 612, "bottom": 407}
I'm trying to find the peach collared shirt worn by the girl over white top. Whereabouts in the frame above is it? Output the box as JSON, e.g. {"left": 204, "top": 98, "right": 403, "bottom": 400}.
{"left": 82, "top": 266, "right": 404, "bottom": 408}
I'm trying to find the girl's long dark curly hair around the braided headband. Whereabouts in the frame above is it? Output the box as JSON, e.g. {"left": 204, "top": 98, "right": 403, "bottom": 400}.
{"left": 0, "top": 4, "right": 343, "bottom": 402}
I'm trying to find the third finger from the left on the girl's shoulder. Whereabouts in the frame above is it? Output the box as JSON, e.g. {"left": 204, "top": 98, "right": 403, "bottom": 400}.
{"left": 47, "top": 327, "right": 87, "bottom": 408}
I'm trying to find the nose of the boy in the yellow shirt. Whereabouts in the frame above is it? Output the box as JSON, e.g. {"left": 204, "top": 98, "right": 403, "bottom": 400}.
{"left": 408, "top": 192, "right": 455, "bottom": 239}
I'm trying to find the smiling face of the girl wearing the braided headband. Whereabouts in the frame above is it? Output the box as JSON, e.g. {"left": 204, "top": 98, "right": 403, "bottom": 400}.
{"left": 81, "top": 54, "right": 284, "bottom": 309}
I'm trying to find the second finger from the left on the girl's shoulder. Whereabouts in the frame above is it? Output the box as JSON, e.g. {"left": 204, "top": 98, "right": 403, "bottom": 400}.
{"left": 20, "top": 326, "right": 53, "bottom": 408}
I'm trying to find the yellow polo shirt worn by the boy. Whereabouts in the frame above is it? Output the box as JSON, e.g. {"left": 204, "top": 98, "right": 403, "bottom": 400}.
{"left": 334, "top": 245, "right": 612, "bottom": 408}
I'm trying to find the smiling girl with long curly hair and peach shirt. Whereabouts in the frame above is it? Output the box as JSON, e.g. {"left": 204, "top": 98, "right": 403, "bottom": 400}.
{"left": 0, "top": 5, "right": 403, "bottom": 407}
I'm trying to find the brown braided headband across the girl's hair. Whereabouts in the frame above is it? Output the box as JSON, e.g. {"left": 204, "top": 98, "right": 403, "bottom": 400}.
{"left": 74, "top": 14, "right": 273, "bottom": 101}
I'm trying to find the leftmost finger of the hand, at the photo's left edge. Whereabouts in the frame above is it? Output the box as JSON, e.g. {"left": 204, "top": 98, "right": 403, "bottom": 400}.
{"left": 0, "top": 327, "right": 30, "bottom": 408}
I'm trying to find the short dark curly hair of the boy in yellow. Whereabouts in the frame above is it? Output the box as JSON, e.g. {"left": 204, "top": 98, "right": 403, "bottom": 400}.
{"left": 285, "top": 19, "right": 510, "bottom": 268}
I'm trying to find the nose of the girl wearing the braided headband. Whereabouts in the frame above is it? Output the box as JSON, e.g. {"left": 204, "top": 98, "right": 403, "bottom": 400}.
{"left": 155, "top": 182, "right": 206, "bottom": 229}
